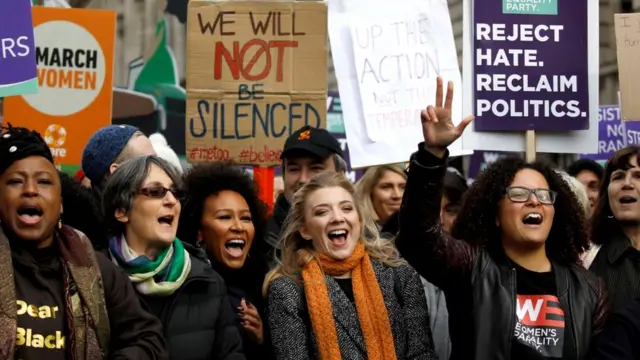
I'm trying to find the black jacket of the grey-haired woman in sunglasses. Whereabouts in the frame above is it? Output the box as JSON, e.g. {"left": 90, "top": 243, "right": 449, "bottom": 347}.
{"left": 105, "top": 243, "right": 245, "bottom": 360}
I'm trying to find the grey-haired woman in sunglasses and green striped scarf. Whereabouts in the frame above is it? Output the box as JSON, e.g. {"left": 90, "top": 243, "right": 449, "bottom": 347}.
{"left": 103, "top": 156, "right": 245, "bottom": 360}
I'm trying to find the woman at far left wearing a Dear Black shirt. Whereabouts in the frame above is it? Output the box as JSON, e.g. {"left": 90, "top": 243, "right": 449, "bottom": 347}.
{"left": 0, "top": 125, "right": 168, "bottom": 360}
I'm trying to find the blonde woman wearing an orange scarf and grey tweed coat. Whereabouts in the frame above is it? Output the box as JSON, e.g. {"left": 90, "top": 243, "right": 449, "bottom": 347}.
{"left": 265, "top": 171, "right": 437, "bottom": 360}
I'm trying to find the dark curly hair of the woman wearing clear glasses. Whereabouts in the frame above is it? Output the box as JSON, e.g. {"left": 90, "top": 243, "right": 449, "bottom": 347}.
{"left": 451, "top": 157, "right": 589, "bottom": 265}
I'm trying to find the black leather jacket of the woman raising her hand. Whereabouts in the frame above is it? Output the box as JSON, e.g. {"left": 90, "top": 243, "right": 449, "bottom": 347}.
{"left": 396, "top": 144, "right": 608, "bottom": 360}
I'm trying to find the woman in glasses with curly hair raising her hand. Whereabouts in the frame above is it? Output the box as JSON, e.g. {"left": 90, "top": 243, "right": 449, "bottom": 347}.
{"left": 396, "top": 78, "right": 607, "bottom": 360}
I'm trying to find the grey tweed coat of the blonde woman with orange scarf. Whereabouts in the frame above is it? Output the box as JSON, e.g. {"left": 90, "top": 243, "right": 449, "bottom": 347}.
{"left": 268, "top": 260, "right": 438, "bottom": 360}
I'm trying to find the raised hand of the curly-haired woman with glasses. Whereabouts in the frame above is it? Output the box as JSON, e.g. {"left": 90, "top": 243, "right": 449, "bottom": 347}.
{"left": 420, "top": 76, "right": 473, "bottom": 157}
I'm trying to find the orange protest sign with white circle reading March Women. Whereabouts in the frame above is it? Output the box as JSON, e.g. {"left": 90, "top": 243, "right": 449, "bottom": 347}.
{"left": 4, "top": 6, "right": 116, "bottom": 165}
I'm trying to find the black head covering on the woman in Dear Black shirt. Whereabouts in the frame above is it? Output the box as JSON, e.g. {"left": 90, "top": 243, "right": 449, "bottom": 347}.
{"left": 0, "top": 123, "right": 53, "bottom": 174}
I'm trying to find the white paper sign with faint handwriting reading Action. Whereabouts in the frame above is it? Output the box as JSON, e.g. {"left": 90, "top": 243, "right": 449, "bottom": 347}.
{"left": 329, "top": 0, "right": 472, "bottom": 168}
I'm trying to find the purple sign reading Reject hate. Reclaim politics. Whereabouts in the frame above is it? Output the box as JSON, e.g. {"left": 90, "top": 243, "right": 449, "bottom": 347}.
{"left": 473, "top": 0, "right": 589, "bottom": 131}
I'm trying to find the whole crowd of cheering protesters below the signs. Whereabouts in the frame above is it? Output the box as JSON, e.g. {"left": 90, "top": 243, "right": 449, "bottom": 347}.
{"left": 0, "top": 79, "right": 640, "bottom": 360}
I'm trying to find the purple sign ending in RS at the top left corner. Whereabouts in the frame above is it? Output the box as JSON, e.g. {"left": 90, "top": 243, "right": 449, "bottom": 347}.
{"left": 0, "top": 0, "right": 38, "bottom": 97}
